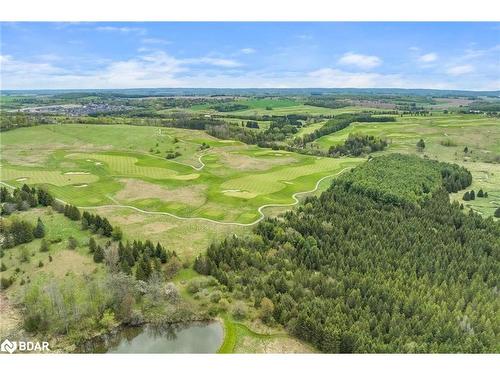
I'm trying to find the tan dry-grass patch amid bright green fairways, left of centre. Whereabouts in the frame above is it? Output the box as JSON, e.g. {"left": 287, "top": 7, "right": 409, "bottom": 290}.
{"left": 115, "top": 179, "right": 207, "bottom": 206}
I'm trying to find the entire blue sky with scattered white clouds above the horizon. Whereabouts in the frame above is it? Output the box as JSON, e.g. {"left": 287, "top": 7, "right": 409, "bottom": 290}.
{"left": 0, "top": 22, "right": 500, "bottom": 90}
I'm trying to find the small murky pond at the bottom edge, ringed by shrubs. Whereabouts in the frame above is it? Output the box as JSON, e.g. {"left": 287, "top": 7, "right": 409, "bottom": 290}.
{"left": 87, "top": 322, "right": 224, "bottom": 353}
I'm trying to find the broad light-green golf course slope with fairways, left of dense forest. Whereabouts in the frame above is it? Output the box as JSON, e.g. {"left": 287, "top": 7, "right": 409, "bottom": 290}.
{"left": 2, "top": 124, "right": 362, "bottom": 224}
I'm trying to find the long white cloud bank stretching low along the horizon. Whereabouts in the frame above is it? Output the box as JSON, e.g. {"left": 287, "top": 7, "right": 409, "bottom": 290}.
{"left": 0, "top": 50, "right": 500, "bottom": 90}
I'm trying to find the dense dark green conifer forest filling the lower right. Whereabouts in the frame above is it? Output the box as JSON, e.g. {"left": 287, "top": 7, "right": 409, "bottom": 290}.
{"left": 195, "top": 155, "right": 500, "bottom": 353}
